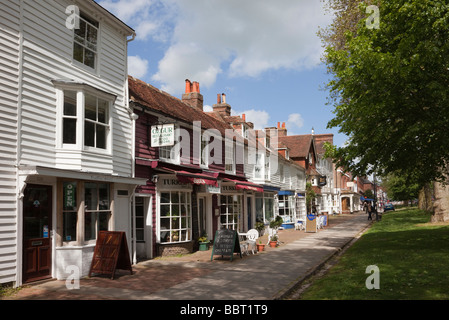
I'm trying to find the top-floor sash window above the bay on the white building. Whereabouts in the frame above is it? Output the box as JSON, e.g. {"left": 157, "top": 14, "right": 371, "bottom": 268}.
{"left": 73, "top": 13, "right": 99, "bottom": 69}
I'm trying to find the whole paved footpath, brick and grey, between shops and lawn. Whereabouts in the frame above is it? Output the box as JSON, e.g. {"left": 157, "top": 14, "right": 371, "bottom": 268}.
{"left": 5, "top": 213, "right": 371, "bottom": 300}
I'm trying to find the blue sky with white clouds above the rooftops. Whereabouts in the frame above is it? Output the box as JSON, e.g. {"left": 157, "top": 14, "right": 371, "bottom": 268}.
{"left": 97, "top": 0, "right": 346, "bottom": 146}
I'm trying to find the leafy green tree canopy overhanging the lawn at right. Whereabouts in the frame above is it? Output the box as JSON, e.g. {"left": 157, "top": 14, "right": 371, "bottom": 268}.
{"left": 322, "top": 0, "right": 449, "bottom": 185}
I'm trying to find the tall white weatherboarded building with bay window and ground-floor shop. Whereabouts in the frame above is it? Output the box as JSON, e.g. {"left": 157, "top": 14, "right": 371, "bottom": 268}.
{"left": 0, "top": 0, "right": 144, "bottom": 286}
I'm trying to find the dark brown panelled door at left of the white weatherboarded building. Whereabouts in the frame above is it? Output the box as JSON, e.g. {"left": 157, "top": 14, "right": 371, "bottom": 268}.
{"left": 22, "top": 185, "right": 52, "bottom": 282}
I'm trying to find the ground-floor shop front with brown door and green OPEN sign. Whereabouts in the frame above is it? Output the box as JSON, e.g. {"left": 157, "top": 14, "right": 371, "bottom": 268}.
{"left": 19, "top": 167, "right": 145, "bottom": 283}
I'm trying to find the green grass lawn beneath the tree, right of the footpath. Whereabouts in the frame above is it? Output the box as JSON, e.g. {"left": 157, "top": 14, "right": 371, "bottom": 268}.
{"left": 301, "top": 208, "right": 449, "bottom": 300}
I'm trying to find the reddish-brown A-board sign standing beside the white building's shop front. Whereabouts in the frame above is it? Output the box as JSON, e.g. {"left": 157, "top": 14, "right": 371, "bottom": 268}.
{"left": 89, "top": 231, "right": 133, "bottom": 279}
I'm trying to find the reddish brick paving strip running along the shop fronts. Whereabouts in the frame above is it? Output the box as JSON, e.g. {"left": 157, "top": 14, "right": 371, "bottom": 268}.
{"left": 2, "top": 215, "right": 364, "bottom": 300}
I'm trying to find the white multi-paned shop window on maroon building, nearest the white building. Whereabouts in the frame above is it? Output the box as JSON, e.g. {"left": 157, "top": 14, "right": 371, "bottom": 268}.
{"left": 159, "top": 191, "right": 192, "bottom": 243}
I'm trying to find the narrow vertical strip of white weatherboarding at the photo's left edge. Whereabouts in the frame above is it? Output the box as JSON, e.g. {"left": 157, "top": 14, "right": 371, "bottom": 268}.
{"left": 0, "top": 0, "right": 20, "bottom": 283}
